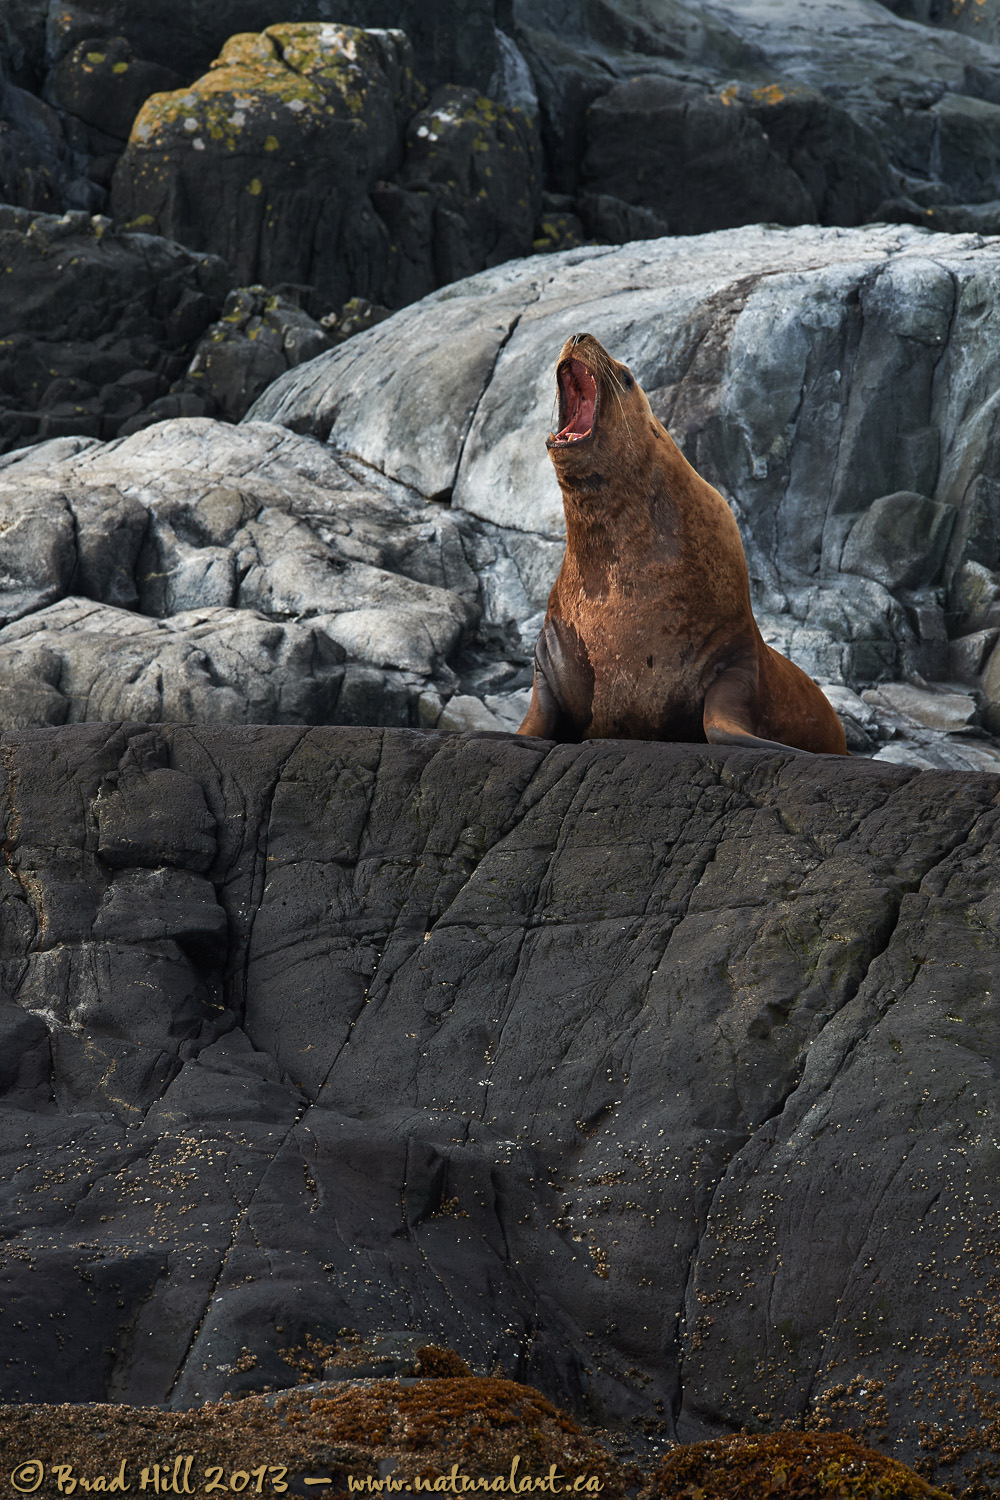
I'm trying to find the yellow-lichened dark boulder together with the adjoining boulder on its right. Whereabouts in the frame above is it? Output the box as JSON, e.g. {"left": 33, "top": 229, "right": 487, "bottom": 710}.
{"left": 111, "top": 23, "right": 540, "bottom": 306}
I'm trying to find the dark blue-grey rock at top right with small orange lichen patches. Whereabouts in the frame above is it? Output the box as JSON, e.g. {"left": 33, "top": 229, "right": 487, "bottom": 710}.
{"left": 513, "top": 0, "right": 1000, "bottom": 233}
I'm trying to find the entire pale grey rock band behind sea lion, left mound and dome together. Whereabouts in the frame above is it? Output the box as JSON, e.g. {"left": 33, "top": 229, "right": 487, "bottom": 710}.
{"left": 0, "top": 228, "right": 1000, "bottom": 770}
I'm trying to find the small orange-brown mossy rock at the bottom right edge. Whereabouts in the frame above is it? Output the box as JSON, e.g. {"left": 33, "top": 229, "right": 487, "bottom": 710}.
{"left": 642, "top": 1433, "right": 949, "bottom": 1500}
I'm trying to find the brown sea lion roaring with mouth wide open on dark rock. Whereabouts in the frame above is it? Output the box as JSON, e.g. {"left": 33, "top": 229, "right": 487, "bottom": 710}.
{"left": 517, "top": 333, "right": 847, "bottom": 755}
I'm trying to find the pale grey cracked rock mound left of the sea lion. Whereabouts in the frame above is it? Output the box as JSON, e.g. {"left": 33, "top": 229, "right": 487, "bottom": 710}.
{"left": 0, "top": 420, "right": 479, "bottom": 728}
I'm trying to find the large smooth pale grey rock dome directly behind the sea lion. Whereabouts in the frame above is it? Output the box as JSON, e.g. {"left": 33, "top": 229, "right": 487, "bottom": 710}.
{"left": 245, "top": 227, "right": 1000, "bottom": 762}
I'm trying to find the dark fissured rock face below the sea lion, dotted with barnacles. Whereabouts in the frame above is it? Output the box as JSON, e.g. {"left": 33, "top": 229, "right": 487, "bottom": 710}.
{"left": 0, "top": 725, "right": 1000, "bottom": 1488}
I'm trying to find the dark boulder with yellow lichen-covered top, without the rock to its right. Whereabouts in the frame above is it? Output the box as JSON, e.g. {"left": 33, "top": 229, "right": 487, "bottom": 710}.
{"left": 112, "top": 23, "right": 421, "bottom": 302}
